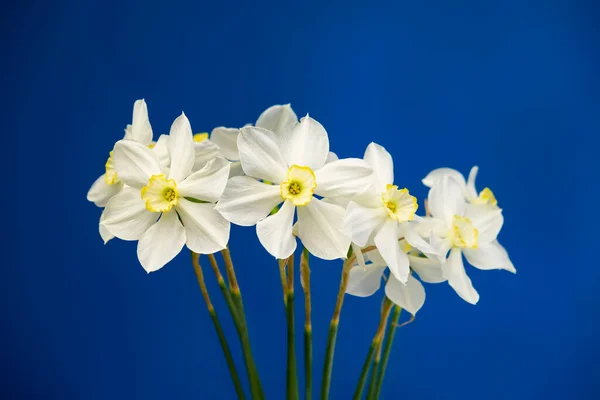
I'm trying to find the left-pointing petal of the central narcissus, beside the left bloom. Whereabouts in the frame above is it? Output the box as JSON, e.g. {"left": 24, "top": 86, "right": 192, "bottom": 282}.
{"left": 217, "top": 176, "right": 283, "bottom": 226}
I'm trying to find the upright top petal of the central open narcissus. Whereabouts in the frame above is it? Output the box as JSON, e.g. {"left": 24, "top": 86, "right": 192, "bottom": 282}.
{"left": 281, "top": 116, "right": 329, "bottom": 171}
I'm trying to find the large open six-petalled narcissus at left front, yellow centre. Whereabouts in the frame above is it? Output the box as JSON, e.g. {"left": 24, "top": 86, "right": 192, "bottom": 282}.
{"left": 102, "top": 113, "right": 230, "bottom": 272}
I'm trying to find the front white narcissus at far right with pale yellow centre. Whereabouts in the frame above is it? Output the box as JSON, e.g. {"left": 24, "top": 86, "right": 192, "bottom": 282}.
{"left": 419, "top": 175, "right": 516, "bottom": 304}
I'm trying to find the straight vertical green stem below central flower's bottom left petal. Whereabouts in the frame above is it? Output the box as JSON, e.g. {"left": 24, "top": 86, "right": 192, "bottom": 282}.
{"left": 285, "top": 254, "right": 300, "bottom": 400}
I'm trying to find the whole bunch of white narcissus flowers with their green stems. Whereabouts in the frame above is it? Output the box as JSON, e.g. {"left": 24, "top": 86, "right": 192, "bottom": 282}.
{"left": 87, "top": 100, "right": 516, "bottom": 399}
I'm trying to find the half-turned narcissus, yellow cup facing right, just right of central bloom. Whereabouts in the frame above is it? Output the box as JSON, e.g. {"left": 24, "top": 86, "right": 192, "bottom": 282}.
{"left": 344, "top": 143, "right": 436, "bottom": 283}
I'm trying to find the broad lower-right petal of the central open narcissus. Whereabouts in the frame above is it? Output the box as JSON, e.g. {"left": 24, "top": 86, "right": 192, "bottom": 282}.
{"left": 298, "top": 198, "right": 351, "bottom": 260}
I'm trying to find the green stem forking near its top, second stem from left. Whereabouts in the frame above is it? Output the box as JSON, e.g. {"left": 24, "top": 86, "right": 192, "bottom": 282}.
{"left": 209, "top": 250, "right": 265, "bottom": 399}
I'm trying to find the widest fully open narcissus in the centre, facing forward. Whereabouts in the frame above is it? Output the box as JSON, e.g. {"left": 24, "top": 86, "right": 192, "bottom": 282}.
{"left": 217, "top": 116, "right": 373, "bottom": 260}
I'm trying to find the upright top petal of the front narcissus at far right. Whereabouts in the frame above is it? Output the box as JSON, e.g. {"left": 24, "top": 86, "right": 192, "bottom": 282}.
{"left": 427, "top": 176, "right": 465, "bottom": 225}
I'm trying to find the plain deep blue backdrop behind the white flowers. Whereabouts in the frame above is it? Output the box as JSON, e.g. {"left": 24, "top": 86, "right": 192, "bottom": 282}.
{"left": 0, "top": 0, "right": 600, "bottom": 400}
